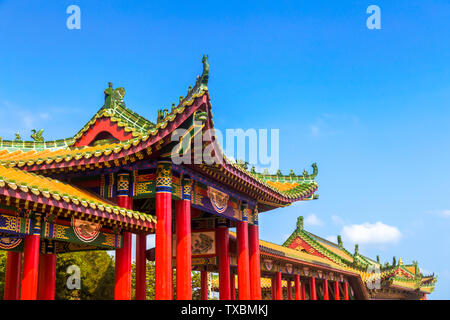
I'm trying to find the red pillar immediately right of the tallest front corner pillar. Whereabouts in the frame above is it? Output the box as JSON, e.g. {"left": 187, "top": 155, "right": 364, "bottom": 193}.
{"left": 175, "top": 178, "right": 192, "bottom": 300}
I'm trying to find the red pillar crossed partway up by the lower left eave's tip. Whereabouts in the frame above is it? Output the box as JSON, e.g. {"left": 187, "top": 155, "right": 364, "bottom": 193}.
{"left": 114, "top": 173, "right": 133, "bottom": 300}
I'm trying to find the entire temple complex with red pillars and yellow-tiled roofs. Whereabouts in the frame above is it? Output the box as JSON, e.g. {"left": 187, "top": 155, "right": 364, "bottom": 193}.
{"left": 0, "top": 57, "right": 436, "bottom": 300}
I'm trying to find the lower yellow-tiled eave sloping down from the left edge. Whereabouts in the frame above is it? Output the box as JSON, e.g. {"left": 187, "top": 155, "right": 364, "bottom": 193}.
{"left": 0, "top": 165, "right": 156, "bottom": 233}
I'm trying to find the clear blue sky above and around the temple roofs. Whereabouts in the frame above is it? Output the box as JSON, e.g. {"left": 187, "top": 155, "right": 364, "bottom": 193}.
{"left": 0, "top": 0, "right": 450, "bottom": 299}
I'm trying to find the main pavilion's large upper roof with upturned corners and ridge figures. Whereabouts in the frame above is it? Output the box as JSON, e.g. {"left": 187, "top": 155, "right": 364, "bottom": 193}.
{"left": 0, "top": 57, "right": 318, "bottom": 211}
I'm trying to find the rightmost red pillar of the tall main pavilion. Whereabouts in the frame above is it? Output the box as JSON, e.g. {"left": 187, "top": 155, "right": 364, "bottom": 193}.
{"left": 248, "top": 209, "right": 262, "bottom": 300}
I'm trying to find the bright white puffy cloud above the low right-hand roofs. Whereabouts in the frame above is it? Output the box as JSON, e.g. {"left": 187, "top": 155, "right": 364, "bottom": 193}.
{"left": 342, "top": 221, "right": 402, "bottom": 244}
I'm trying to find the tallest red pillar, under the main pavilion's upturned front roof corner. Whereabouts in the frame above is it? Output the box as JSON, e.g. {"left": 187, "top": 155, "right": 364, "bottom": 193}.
{"left": 155, "top": 160, "right": 172, "bottom": 300}
